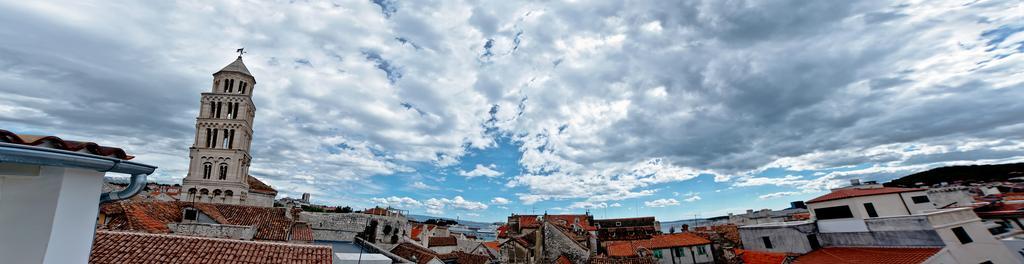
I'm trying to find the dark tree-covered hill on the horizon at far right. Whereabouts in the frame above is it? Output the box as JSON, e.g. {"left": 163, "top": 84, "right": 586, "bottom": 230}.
{"left": 885, "top": 163, "right": 1024, "bottom": 187}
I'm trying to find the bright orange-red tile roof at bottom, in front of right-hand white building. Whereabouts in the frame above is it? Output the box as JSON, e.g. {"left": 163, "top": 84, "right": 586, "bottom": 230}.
{"left": 793, "top": 248, "right": 941, "bottom": 264}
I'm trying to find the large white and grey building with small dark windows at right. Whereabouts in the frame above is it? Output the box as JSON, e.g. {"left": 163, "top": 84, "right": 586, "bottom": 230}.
{"left": 739, "top": 181, "right": 1017, "bottom": 263}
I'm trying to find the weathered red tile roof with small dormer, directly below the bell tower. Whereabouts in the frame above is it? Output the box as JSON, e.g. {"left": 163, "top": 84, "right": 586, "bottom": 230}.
{"left": 100, "top": 201, "right": 293, "bottom": 241}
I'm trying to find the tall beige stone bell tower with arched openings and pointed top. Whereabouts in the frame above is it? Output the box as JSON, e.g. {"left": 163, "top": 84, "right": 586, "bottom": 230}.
{"left": 181, "top": 56, "right": 278, "bottom": 207}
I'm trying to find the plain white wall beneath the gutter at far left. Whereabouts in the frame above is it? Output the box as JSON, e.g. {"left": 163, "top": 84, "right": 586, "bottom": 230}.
{"left": 0, "top": 164, "right": 103, "bottom": 263}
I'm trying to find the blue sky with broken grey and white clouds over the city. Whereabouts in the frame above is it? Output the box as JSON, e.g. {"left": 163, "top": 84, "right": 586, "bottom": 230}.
{"left": 0, "top": 0, "right": 1024, "bottom": 221}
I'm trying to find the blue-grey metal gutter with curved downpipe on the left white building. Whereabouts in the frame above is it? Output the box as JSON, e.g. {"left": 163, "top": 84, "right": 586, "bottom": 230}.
{"left": 0, "top": 142, "right": 157, "bottom": 204}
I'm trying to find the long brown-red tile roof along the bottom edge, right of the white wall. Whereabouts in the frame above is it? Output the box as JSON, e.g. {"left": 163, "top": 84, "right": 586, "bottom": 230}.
{"left": 89, "top": 231, "right": 334, "bottom": 264}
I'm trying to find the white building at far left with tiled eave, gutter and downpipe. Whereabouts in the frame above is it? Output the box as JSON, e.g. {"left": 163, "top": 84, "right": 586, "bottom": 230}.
{"left": 0, "top": 130, "right": 156, "bottom": 264}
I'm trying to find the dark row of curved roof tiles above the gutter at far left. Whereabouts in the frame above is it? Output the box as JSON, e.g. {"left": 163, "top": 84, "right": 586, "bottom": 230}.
{"left": 0, "top": 129, "right": 135, "bottom": 160}
